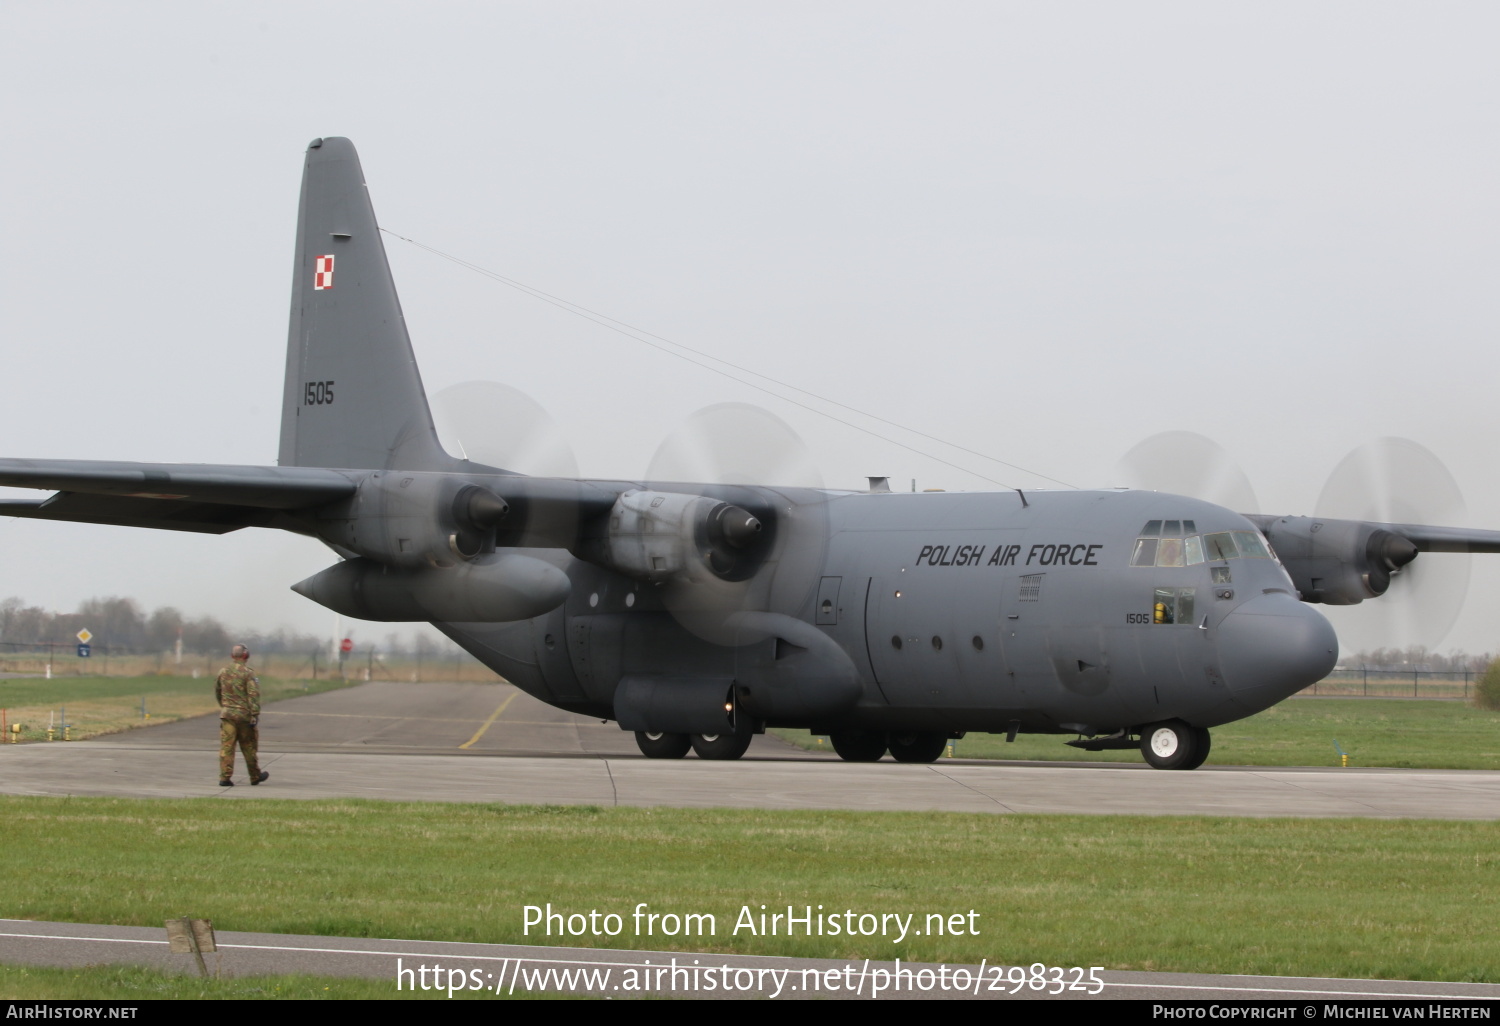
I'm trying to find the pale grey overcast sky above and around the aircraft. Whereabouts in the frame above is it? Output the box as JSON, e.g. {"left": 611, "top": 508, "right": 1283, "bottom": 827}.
{"left": 0, "top": 0, "right": 1500, "bottom": 651}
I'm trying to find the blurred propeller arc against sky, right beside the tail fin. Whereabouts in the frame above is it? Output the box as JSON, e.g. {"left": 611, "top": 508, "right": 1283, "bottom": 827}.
{"left": 432, "top": 381, "right": 578, "bottom": 477}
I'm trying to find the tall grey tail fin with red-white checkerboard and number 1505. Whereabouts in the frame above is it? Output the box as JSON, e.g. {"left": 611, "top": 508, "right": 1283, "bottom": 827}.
{"left": 278, "top": 138, "right": 452, "bottom": 470}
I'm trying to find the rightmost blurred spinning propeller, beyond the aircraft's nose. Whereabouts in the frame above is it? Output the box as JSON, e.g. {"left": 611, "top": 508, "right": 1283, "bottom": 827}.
{"left": 1314, "top": 438, "right": 1470, "bottom": 651}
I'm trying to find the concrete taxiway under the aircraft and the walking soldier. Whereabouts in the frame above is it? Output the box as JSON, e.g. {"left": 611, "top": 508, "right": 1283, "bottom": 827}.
{"left": 0, "top": 684, "right": 1500, "bottom": 819}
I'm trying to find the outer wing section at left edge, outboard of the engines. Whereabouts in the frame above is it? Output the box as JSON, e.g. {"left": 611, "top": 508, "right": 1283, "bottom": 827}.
{"left": 0, "top": 459, "right": 356, "bottom": 534}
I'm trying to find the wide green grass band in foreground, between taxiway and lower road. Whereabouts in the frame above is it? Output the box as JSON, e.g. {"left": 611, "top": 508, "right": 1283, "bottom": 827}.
{"left": 0, "top": 798, "right": 1500, "bottom": 983}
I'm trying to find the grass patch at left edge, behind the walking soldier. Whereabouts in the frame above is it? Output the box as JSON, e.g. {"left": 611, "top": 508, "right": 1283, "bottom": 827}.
{"left": 0, "top": 677, "right": 354, "bottom": 741}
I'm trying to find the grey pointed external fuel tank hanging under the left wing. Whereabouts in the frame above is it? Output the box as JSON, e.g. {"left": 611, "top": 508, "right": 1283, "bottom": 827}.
{"left": 291, "top": 552, "right": 572, "bottom": 624}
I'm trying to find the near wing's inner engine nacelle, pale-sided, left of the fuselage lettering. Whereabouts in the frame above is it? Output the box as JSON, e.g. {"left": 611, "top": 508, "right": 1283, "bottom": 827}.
{"left": 599, "top": 492, "right": 762, "bottom": 582}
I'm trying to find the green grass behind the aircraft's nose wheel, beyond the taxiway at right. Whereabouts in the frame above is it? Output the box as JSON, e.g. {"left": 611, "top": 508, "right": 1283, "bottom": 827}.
{"left": 774, "top": 698, "right": 1500, "bottom": 770}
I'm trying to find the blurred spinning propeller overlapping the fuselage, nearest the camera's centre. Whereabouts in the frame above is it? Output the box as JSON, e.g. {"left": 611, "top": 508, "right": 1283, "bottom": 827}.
{"left": 647, "top": 402, "right": 828, "bottom": 645}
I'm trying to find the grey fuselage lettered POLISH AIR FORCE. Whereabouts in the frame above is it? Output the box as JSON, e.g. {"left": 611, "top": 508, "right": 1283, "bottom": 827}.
{"left": 440, "top": 489, "right": 1338, "bottom": 734}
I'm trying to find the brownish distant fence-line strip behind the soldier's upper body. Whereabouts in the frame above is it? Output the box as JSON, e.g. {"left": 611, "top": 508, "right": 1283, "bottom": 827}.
{"left": 0, "top": 642, "right": 500, "bottom": 683}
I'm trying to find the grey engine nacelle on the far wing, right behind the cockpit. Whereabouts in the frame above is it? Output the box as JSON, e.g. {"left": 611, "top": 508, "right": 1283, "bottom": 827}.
{"left": 1253, "top": 516, "right": 1418, "bottom": 606}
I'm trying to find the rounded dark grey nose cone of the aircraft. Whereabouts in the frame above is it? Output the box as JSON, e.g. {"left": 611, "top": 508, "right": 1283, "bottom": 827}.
{"left": 1218, "top": 591, "right": 1338, "bottom": 710}
